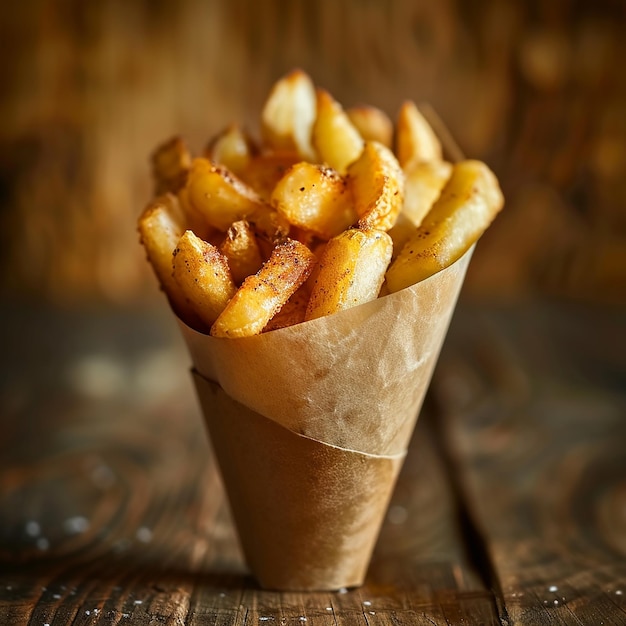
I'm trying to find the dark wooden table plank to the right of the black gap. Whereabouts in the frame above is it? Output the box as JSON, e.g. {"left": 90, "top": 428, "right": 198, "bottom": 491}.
{"left": 433, "top": 300, "right": 626, "bottom": 624}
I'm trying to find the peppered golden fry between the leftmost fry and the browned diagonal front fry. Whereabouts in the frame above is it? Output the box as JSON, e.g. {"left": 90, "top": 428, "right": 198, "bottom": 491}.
{"left": 173, "top": 230, "right": 237, "bottom": 328}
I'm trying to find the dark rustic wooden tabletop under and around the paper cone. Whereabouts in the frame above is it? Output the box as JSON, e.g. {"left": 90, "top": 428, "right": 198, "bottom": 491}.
{"left": 0, "top": 303, "right": 626, "bottom": 626}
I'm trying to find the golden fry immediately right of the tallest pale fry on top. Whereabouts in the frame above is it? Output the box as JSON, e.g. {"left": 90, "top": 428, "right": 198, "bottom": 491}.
{"left": 312, "top": 89, "right": 363, "bottom": 175}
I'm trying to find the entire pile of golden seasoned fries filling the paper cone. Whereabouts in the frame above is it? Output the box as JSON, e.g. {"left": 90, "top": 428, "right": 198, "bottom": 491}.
{"left": 139, "top": 70, "right": 503, "bottom": 338}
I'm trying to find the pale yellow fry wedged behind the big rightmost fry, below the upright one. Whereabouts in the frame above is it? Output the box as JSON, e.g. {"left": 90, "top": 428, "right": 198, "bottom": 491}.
{"left": 402, "top": 161, "right": 452, "bottom": 226}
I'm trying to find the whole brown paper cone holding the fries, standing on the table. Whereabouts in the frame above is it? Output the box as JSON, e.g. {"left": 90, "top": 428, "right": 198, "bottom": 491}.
{"left": 180, "top": 241, "right": 472, "bottom": 590}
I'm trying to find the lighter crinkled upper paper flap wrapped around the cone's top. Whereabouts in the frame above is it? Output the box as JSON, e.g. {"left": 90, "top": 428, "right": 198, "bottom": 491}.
{"left": 179, "top": 250, "right": 472, "bottom": 455}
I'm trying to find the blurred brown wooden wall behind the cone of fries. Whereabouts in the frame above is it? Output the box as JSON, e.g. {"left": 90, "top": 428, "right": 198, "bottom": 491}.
{"left": 0, "top": 0, "right": 626, "bottom": 307}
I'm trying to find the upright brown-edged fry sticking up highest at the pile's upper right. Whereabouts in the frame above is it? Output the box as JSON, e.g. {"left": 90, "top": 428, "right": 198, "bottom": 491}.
{"left": 396, "top": 100, "right": 442, "bottom": 167}
